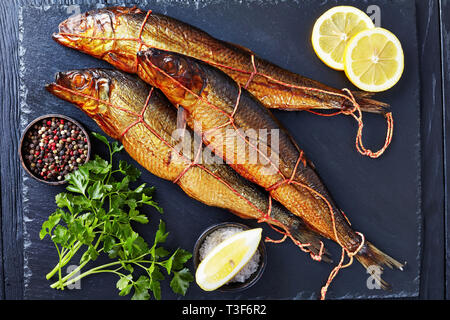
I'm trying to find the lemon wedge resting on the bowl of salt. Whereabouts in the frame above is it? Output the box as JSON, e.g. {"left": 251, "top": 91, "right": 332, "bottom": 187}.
{"left": 195, "top": 228, "right": 262, "bottom": 291}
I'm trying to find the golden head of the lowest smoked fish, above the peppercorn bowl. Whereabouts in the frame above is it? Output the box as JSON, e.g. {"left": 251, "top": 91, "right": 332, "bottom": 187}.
{"left": 46, "top": 69, "right": 127, "bottom": 139}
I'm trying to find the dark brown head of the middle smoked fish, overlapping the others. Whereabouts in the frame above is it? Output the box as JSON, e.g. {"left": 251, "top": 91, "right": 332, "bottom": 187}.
{"left": 137, "top": 48, "right": 206, "bottom": 111}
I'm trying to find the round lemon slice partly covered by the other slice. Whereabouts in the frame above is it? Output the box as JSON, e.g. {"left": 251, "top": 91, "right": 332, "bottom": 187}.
{"left": 311, "top": 6, "right": 374, "bottom": 70}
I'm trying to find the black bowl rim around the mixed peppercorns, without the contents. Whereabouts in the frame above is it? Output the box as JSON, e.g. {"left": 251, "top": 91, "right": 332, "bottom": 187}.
{"left": 19, "top": 114, "right": 91, "bottom": 185}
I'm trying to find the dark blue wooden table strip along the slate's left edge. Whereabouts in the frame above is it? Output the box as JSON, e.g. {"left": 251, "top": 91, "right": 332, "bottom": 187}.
{"left": 0, "top": 1, "right": 23, "bottom": 298}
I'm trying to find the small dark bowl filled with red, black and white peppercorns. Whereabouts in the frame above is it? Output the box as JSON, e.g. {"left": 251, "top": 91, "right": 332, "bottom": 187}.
{"left": 19, "top": 114, "right": 91, "bottom": 185}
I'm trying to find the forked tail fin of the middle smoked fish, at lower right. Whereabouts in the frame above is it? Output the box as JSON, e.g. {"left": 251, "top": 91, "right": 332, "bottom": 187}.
{"left": 355, "top": 241, "right": 404, "bottom": 290}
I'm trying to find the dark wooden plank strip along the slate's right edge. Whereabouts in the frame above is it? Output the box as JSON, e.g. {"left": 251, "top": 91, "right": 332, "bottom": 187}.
{"left": 416, "top": 1, "right": 448, "bottom": 299}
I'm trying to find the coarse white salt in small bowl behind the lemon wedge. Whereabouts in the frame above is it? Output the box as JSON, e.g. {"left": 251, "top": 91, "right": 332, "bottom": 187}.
{"left": 199, "top": 227, "right": 261, "bottom": 283}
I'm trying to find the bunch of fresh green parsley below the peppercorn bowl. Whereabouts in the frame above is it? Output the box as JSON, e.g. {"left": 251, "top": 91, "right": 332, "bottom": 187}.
{"left": 40, "top": 133, "right": 193, "bottom": 300}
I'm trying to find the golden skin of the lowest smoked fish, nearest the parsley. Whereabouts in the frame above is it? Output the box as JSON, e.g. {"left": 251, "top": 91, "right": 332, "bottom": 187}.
{"left": 47, "top": 69, "right": 329, "bottom": 261}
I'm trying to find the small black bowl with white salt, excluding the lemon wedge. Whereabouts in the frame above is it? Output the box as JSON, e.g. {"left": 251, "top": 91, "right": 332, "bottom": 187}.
{"left": 194, "top": 222, "right": 267, "bottom": 292}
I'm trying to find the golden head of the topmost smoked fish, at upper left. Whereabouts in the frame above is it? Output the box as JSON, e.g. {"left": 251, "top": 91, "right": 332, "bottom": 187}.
{"left": 52, "top": 7, "right": 143, "bottom": 72}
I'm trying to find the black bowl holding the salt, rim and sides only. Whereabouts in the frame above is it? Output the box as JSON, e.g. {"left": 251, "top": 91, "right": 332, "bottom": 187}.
{"left": 193, "top": 222, "right": 267, "bottom": 292}
